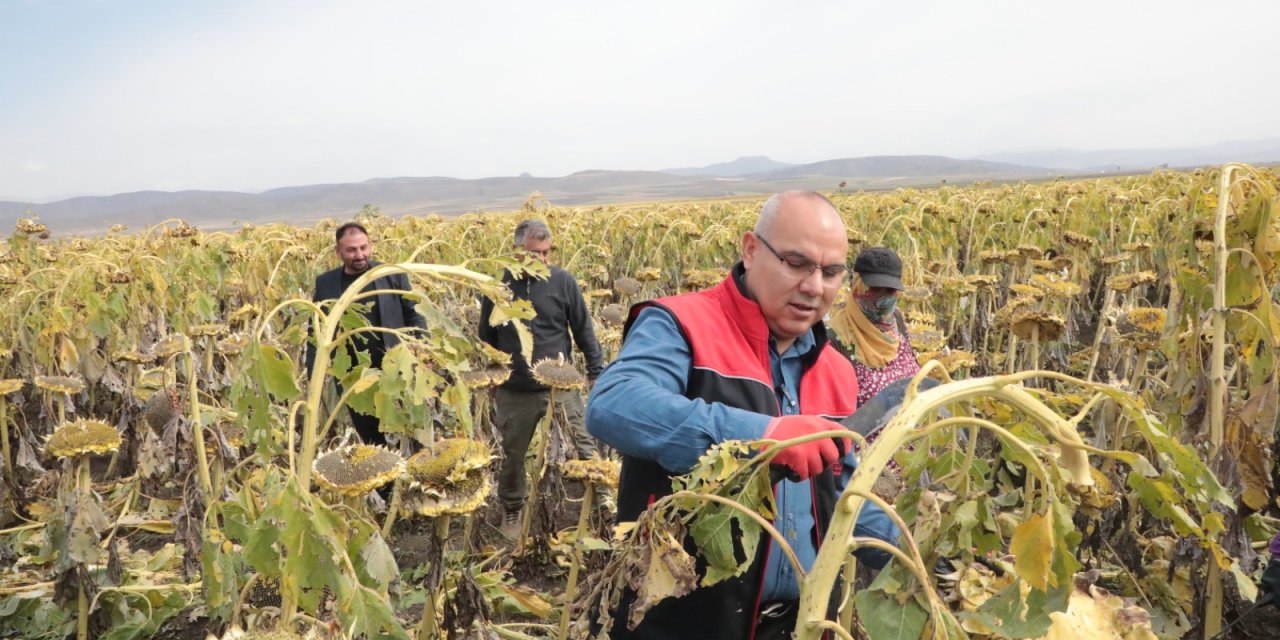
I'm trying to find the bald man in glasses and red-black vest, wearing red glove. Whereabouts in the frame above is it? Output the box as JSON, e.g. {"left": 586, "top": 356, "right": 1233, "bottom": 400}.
{"left": 586, "top": 191, "right": 899, "bottom": 640}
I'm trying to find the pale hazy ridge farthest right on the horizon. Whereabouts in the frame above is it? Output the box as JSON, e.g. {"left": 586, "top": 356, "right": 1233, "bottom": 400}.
{"left": 979, "top": 138, "right": 1280, "bottom": 173}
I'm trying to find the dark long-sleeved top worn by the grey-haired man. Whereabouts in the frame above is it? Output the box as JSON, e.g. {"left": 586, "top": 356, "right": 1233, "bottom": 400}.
{"left": 480, "top": 265, "right": 604, "bottom": 392}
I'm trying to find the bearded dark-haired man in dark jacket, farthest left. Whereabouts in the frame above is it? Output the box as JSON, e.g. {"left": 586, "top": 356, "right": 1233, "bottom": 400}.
{"left": 306, "top": 223, "right": 426, "bottom": 444}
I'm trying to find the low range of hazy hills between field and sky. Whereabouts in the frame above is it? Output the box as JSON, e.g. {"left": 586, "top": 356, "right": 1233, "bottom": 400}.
{"left": 0, "top": 138, "right": 1280, "bottom": 234}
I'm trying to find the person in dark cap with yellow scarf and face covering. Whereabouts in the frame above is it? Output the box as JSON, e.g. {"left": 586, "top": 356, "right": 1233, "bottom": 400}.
{"left": 829, "top": 247, "right": 920, "bottom": 406}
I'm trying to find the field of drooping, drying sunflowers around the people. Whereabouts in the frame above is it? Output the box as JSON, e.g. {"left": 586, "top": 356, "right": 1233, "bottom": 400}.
{"left": 0, "top": 165, "right": 1280, "bottom": 640}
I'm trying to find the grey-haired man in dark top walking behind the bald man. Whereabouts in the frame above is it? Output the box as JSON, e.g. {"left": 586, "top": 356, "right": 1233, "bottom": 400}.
{"left": 480, "top": 220, "right": 603, "bottom": 539}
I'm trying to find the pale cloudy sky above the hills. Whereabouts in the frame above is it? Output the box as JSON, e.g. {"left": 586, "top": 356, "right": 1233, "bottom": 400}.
{"left": 0, "top": 0, "right": 1280, "bottom": 202}
